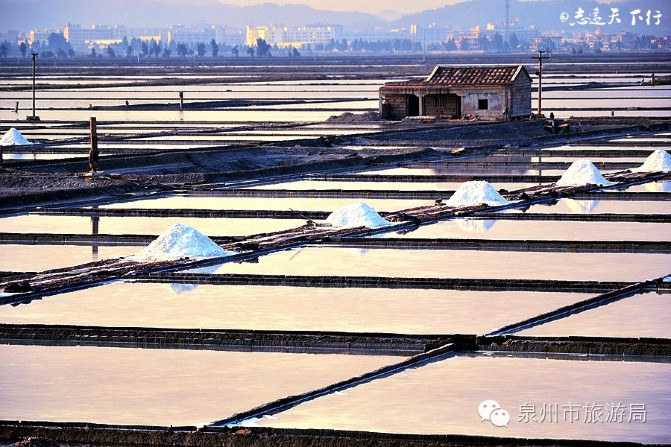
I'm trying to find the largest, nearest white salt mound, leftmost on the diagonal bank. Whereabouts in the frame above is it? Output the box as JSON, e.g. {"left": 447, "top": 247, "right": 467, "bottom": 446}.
{"left": 135, "top": 223, "right": 234, "bottom": 261}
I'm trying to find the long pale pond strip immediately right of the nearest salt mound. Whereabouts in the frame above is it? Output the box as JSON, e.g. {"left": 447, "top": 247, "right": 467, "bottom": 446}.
{"left": 205, "top": 246, "right": 671, "bottom": 281}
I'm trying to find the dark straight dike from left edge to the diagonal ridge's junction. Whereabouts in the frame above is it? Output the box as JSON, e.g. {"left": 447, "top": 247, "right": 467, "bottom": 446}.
{"left": 0, "top": 324, "right": 460, "bottom": 356}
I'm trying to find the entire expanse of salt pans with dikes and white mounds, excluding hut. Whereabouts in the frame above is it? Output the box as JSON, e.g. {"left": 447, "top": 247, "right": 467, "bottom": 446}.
{"left": 0, "top": 54, "right": 671, "bottom": 445}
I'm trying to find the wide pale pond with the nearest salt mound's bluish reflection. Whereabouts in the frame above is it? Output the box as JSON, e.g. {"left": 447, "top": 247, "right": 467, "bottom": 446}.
{"left": 0, "top": 284, "right": 591, "bottom": 334}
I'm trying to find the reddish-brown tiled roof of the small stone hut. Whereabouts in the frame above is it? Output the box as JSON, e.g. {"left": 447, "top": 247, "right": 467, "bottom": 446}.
{"left": 425, "top": 65, "right": 528, "bottom": 86}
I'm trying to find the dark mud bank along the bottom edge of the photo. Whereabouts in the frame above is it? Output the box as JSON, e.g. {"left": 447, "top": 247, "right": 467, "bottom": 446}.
{"left": 0, "top": 421, "right": 642, "bottom": 447}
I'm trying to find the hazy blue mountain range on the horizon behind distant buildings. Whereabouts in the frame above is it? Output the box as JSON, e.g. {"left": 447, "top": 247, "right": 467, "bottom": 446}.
{"left": 0, "top": 0, "right": 671, "bottom": 35}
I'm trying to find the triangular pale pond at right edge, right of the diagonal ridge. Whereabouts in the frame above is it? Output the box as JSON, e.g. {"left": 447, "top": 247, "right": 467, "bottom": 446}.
{"left": 517, "top": 292, "right": 671, "bottom": 339}
